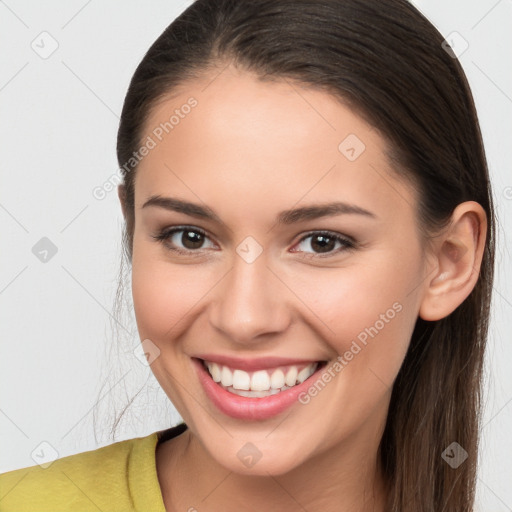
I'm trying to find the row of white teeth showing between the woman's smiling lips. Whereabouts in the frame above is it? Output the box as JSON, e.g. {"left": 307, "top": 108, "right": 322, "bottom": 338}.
{"left": 199, "top": 359, "right": 327, "bottom": 398}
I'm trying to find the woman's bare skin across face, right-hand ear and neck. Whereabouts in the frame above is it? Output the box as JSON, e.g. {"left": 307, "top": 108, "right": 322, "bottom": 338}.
{"left": 119, "top": 66, "right": 485, "bottom": 512}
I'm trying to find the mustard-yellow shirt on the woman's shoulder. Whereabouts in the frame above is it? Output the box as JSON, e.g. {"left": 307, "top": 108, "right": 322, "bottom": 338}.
{"left": 0, "top": 423, "right": 186, "bottom": 512}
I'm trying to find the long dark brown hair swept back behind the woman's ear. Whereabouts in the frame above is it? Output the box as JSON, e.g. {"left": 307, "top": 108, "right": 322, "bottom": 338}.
{"left": 111, "top": 0, "right": 495, "bottom": 512}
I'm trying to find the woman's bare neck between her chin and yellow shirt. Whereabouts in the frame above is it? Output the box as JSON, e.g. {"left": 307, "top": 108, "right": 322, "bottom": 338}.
{"left": 157, "top": 420, "right": 386, "bottom": 512}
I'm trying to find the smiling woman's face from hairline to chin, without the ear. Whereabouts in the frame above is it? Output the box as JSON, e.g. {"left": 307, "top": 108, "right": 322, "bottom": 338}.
{"left": 127, "top": 67, "right": 427, "bottom": 475}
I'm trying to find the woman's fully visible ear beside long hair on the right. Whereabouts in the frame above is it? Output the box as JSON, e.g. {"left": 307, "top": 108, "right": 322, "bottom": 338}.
{"left": 419, "top": 201, "right": 487, "bottom": 321}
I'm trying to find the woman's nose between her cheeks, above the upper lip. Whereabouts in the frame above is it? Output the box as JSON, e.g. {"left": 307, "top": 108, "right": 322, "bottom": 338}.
{"left": 209, "top": 252, "right": 292, "bottom": 345}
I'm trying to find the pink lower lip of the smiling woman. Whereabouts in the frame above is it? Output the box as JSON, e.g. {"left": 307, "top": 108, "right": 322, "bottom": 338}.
{"left": 192, "top": 358, "right": 325, "bottom": 420}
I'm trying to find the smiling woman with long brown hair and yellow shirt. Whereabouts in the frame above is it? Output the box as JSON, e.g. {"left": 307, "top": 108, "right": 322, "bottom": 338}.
{"left": 0, "top": 0, "right": 494, "bottom": 512}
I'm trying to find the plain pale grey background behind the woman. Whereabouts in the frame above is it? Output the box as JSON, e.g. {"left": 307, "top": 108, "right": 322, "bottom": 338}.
{"left": 0, "top": 0, "right": 512, "bottom": 512}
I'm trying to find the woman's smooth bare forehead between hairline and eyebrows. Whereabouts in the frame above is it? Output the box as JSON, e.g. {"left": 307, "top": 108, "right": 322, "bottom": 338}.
{"left": 135, "top": 67, "right": 415, "bottom": 228}
